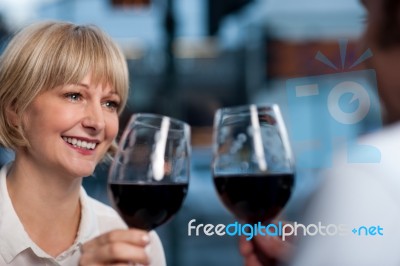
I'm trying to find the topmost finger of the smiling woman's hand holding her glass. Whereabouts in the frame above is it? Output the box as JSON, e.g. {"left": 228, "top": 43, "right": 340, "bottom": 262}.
{"left": 82, "top": 229, "right": 150, "bottom": 252}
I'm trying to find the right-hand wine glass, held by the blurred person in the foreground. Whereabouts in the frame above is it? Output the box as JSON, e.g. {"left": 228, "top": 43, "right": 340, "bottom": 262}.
{"left": 212, "top": 104, "right": 295, "bottom": 224}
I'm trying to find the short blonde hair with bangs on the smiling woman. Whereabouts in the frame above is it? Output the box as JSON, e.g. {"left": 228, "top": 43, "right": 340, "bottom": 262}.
{"left": 0, "top": 21, "right": 129, "bottom": 158}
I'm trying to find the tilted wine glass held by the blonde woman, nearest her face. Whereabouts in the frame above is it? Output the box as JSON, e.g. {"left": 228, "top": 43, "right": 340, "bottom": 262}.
{"left": 108, "top": 113, "right": 191, "bottom": 230}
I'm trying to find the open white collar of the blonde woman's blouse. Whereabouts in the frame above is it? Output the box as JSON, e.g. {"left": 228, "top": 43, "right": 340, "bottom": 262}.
{"left": 0, "top": 163, "right": 99, "bottom": 263}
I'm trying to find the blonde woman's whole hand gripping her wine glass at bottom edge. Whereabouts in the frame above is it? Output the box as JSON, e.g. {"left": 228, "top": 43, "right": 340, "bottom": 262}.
{"left": 79, "top": 229, "right": 150, "bottom": 266}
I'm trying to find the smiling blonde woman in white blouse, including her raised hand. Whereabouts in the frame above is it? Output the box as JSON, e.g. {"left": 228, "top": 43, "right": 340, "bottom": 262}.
{"left": 0, "top": 22, "right": 165, "bottom": 265}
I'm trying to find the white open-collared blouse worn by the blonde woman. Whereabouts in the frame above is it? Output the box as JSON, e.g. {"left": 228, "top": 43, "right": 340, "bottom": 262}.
{"left": 0, "top": 164, "right": 166, "bottom": 266}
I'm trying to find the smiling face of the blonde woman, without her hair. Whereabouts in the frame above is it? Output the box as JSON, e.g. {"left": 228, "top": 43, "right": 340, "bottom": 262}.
{"left": 16, "top": 75, "right": 121, "bottom": 177}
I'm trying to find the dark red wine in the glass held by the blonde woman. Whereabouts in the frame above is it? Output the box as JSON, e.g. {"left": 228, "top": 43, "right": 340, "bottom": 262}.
{"left": 110, "top": 183, "right": 188, "bottom": 230}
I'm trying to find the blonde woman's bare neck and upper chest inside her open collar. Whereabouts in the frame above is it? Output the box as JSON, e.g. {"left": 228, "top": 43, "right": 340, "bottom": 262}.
{"left": 7, "top": 155, "right": 81, "bottom": 256}
